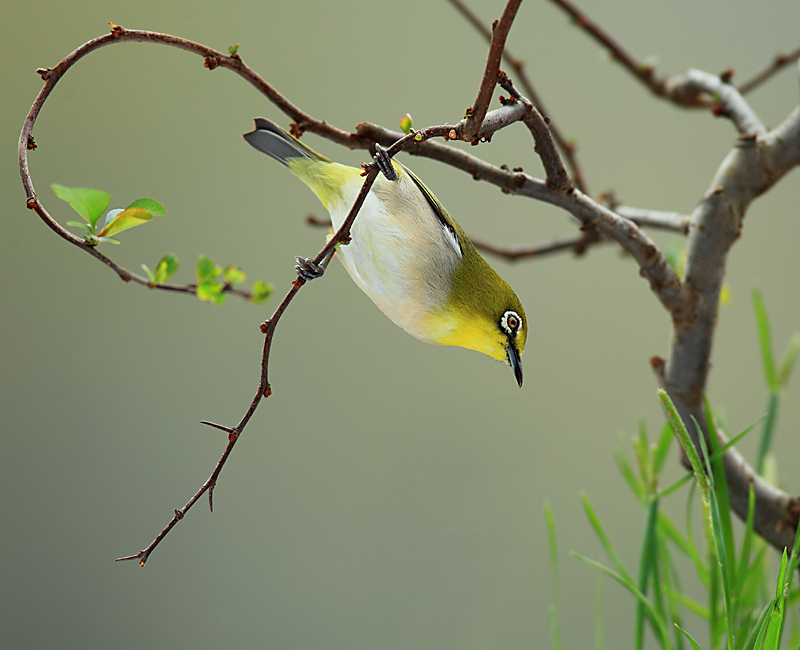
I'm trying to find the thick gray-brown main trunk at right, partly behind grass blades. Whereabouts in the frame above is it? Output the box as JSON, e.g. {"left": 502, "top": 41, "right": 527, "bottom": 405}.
{"left": 662, "top": 107, "right": 800, "bottom": 549}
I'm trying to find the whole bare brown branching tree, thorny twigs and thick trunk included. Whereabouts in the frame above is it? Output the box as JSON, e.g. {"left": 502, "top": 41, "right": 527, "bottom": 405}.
{"left": 19, "top": 0, "right": 800, "bottom": 566}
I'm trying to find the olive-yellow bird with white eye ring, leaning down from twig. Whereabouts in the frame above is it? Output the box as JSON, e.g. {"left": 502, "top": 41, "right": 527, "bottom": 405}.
{"left": 243, "top": 118, "right": 528, "bottom": 387}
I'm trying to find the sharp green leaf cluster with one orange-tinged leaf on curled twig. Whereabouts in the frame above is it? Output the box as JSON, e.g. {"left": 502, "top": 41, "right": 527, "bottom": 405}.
{"left": 50, "top": 183, "right": 166, "bottom": 246}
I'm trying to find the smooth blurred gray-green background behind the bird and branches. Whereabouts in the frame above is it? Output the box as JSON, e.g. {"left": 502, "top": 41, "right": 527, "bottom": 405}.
{"left": 0, "top": 0, "right": 800, "bottom": 649}
